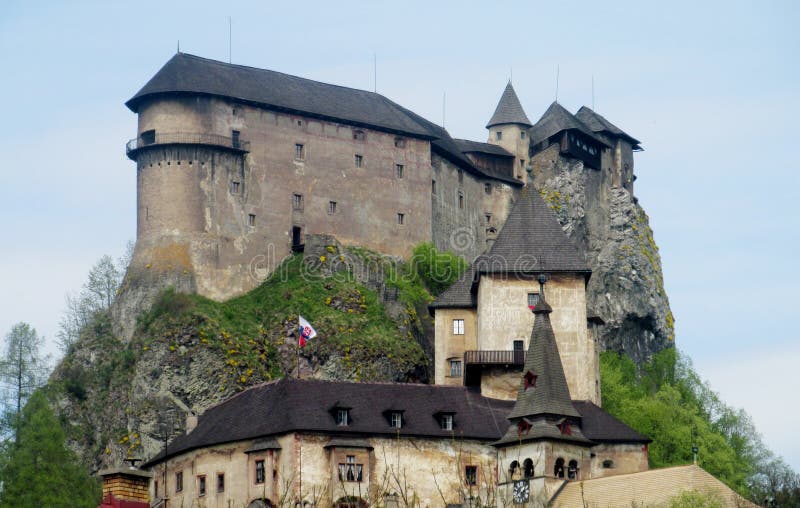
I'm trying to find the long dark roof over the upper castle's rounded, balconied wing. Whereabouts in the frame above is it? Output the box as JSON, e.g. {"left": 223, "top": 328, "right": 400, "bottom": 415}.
{"left": 126, "top": 53, "right": 433, "bottom": 138}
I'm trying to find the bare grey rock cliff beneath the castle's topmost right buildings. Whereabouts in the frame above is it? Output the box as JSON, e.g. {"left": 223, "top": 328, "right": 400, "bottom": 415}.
{"left": 532, "top": 145, "right": 675, "bottom": 365}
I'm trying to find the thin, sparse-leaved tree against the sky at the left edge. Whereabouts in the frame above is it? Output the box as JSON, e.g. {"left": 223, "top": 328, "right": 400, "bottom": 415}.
{"left": 0, "top": 323, "right": 49, "bottom": 437}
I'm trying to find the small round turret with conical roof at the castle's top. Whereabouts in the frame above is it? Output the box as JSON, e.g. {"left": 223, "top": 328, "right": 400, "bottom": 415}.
{"left": 486, "top": 81, "right": 533, "bottom": 182}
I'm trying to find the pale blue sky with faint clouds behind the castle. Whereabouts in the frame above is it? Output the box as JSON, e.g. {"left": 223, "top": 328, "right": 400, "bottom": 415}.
{"left": 0, "top": 0, "right": 800, "bottom": 471}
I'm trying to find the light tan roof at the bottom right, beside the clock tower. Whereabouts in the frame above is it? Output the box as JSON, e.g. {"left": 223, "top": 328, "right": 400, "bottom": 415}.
{"left": 548, "top": 465, "right": 756, "bottom": 508}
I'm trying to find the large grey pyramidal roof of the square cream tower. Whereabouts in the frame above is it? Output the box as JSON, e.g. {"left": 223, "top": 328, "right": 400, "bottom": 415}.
{"left": 473, "top": 187, "right": 591, "bottom": 277}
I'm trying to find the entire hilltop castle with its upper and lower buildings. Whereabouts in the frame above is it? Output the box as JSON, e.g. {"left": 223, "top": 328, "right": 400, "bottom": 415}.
{"left": 100, "top": 53, "right": 742, "bottom": 508}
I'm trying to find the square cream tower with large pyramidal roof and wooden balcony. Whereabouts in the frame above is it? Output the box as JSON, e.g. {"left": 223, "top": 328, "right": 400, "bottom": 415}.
{"left": 430, "top": 186, "right": 600, "bottom": 404}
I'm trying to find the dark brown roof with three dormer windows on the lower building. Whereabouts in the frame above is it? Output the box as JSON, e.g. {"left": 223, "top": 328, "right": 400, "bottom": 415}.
{"left": 148, "top": 378, "right": 511, "bottom": 464}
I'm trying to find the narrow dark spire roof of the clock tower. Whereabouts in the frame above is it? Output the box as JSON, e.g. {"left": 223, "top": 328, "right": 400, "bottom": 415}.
{"left": 508, "top": 298, "right": 580, "bottom": 422}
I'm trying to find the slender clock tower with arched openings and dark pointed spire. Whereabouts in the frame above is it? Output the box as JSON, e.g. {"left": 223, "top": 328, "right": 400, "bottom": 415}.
{"left": 495, "top": 297, "right": 594, "bottom": 506}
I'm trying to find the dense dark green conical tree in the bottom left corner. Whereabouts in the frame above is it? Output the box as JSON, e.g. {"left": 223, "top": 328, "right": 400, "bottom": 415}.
{"left": 0, "top": 390, "right": 100, "bottom": 508}
